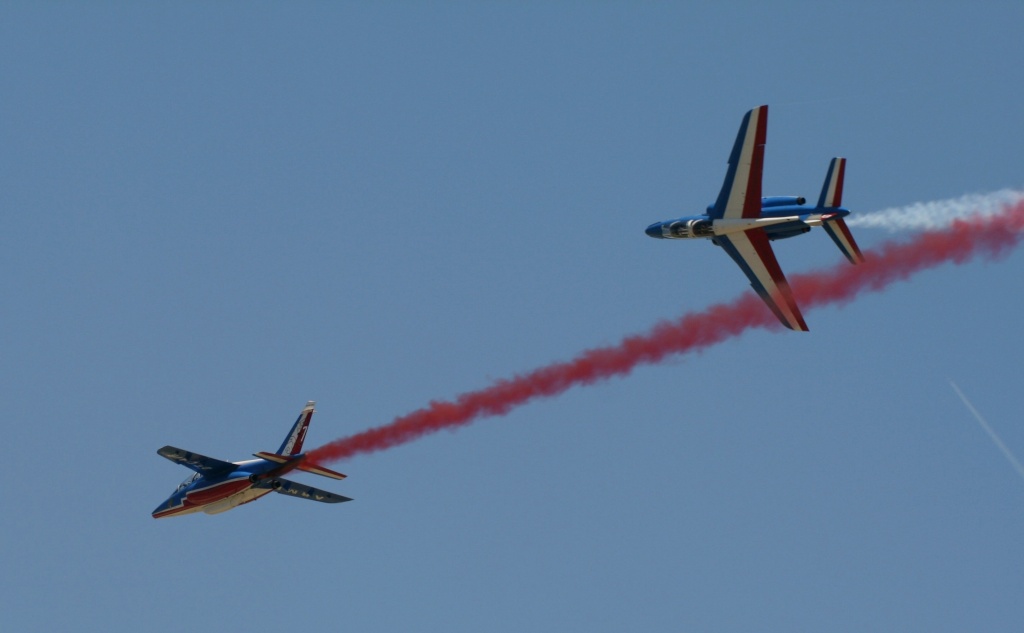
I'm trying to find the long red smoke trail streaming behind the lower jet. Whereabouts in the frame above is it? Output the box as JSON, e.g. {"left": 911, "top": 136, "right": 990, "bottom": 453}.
{"left": 308, "top": 202, "right": 1024, "bottom": 462}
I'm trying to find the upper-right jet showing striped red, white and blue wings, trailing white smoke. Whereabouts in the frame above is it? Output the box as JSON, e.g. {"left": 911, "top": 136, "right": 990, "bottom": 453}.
{"left": 646, "top": 106, "right": 864, "bottom": 332}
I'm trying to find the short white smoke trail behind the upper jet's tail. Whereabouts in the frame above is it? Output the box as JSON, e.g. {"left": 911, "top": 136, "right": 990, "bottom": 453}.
{"left": 847, "top": 189, "right": 1024, "bottom": 233}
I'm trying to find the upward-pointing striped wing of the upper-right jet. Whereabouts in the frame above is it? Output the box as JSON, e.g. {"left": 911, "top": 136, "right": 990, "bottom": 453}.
{"left": 710, "top": 106, "right": 768, "bottom": 219}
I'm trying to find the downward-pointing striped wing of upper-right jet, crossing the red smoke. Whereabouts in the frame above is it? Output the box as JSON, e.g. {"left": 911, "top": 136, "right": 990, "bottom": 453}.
{"left": 715, "top": 228, "right": 807, "bottom": 332}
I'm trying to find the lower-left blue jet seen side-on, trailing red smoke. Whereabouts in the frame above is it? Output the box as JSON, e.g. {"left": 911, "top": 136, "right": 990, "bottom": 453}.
{"left": 153, "top": 402, "right": 351, "bottom": 518}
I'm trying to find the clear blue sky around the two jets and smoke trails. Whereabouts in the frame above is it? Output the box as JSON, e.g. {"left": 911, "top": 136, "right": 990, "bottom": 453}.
{"left": 0, "top": 1, "right": 1024, "bottom": 632}
